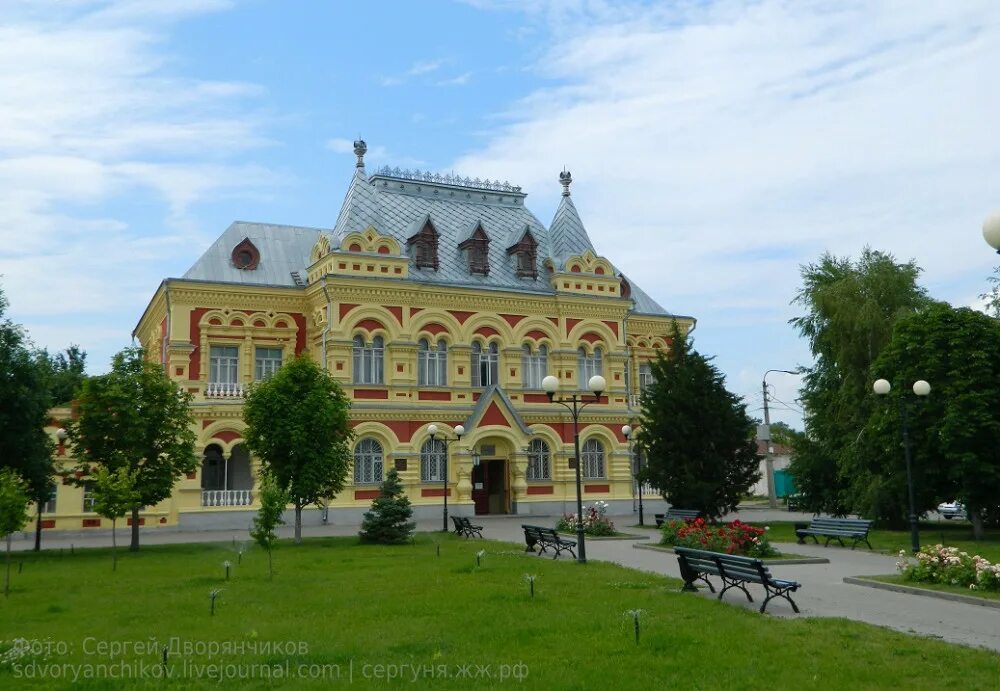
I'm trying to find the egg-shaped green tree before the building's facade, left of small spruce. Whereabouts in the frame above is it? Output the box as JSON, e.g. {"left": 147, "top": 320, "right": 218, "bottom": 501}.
{"left": 243, "top": 355, "right": 353, "bottom": 544}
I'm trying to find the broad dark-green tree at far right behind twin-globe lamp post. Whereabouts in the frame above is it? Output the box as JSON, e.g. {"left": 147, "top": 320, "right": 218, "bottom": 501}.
{"left": 861, "top": 304, "right": 1000, "bottom": 539}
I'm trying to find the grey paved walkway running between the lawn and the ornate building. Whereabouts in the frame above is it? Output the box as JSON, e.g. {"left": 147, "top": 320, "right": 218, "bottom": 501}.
{"left": 13, "top": 509, "right": 1000, "bottom": 651}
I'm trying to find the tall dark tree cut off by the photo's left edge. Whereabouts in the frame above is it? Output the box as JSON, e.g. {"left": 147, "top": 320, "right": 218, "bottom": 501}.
{"left": 0, "top": 282, "right": 55, "bottom": 551}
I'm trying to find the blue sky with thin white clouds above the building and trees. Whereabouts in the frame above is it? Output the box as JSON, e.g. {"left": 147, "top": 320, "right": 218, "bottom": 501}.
{"left": 0, "top": 0, "right": 1000, "bottom": 428}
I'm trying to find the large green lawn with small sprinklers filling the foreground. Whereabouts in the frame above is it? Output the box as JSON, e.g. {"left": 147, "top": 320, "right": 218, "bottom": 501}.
{"left": 0, "top": 535, "right": 1000, "bottom": 691}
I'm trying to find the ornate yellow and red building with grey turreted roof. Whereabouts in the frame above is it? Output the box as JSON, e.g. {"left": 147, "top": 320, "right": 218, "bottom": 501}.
{"left": 41, "top": 141, "right": 694, "bottom": 528}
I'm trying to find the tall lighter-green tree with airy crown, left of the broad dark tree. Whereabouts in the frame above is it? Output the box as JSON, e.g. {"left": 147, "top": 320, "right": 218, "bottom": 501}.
{"left": 790, "top": 247, "right": 931, "bottom": 515}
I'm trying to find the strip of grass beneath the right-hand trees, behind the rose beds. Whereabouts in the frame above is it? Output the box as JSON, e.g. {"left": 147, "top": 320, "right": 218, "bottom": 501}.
{"left": 752, "top": 521, "right": 1000, "bottom": 563}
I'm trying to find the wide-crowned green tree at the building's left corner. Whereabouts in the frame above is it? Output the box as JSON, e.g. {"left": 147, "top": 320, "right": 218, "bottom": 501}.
{"left": 66, "top": 348, "right": 198, "bottom": 551}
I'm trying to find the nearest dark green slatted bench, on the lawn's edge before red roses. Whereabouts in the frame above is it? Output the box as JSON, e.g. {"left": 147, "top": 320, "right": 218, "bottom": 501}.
{"left": 674, "top": 547, "right": 801, "bottom": 614}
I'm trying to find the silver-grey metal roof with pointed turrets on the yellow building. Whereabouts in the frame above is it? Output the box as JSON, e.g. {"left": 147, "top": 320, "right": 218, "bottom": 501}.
{"left": 184, "top": 162, "right": 669, "bottom": 315}
